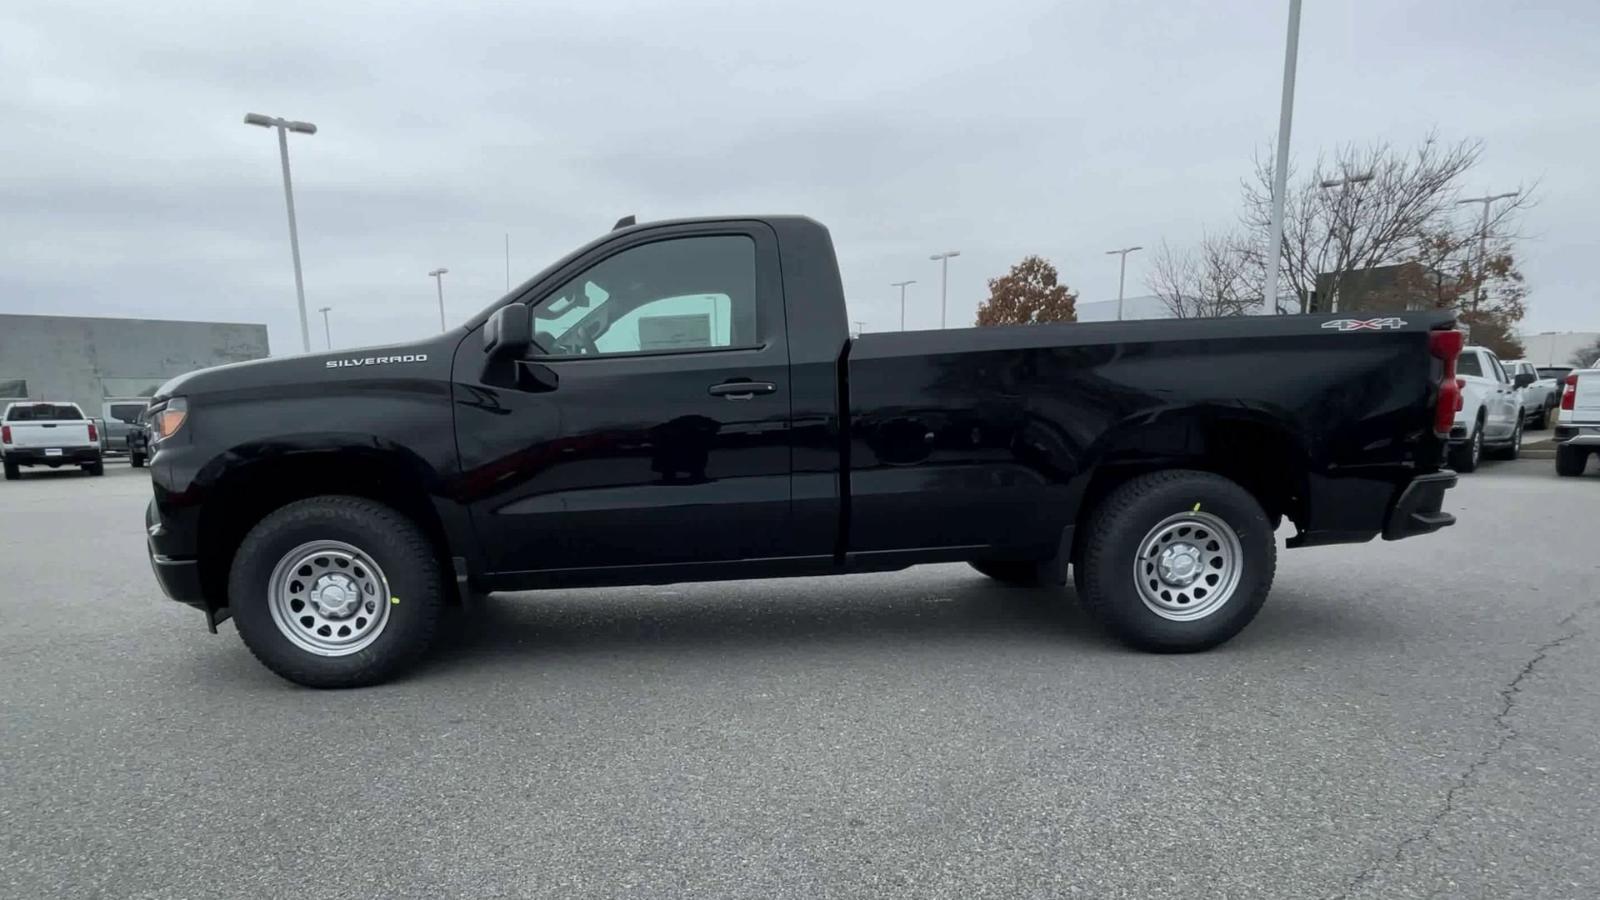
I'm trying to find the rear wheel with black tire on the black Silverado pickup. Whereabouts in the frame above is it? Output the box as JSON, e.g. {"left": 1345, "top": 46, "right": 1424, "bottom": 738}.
{"left": 1074, "top": 469, "right": 1278, "bottom": 653}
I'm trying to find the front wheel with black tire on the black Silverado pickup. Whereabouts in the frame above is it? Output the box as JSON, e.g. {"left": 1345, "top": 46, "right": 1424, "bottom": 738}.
{"left": 227, "top": 496, "right": 446, "bottom": 687}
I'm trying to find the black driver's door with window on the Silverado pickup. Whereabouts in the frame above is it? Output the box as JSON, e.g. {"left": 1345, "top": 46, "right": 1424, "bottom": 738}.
{"left": 454, "top": 223, "right": 790, "bottom": 572}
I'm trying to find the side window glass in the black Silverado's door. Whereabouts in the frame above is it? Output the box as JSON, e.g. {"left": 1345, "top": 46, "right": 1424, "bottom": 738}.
{"left": 533, "top": 235, "right": 760, "bottom": 356}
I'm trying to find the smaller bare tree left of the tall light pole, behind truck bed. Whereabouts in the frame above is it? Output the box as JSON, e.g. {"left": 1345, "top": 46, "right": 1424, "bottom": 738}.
{"left": 1146, "top": 234, "right": 1261, "bottom": 319}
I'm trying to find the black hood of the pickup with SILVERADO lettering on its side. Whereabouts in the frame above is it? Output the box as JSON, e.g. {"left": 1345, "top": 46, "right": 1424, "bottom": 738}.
{"left": 150, "top": 328, "right": 464, "bottom": 397}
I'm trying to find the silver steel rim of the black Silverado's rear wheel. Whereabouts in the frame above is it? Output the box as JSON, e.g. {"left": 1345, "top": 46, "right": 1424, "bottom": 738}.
{"left": 1133, "top": 511, "right": 1245, "bottom": 621}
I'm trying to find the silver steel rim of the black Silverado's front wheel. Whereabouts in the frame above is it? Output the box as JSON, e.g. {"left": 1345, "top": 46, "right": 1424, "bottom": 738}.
{"left": 267, "top": 541, "right": 390, "bottom": 657}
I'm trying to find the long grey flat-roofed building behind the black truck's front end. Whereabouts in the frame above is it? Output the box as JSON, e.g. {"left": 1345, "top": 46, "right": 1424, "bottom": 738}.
{"left": 0, "top": 314, "right": 267, "bottom": 416}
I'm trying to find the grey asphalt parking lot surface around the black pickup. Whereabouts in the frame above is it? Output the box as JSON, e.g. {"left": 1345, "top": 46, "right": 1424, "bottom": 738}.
{"left": 0, "top": 460, "right": 1600, "bottom": 898}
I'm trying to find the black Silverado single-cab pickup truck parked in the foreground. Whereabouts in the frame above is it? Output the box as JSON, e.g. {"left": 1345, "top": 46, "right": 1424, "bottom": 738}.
{"left": 146, "top": 216, "right": 1461, "bottom": 687}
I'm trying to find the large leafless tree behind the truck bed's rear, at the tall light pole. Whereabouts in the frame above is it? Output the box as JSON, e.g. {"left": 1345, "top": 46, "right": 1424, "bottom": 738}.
{"left": 1243, "top": 135, "right": 1533, "bottom": 312}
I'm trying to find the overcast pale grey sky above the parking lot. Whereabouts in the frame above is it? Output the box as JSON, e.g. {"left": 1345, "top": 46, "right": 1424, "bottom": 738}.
{"left": 0, "top": 0, "right": 1600, "bottom": 352}
